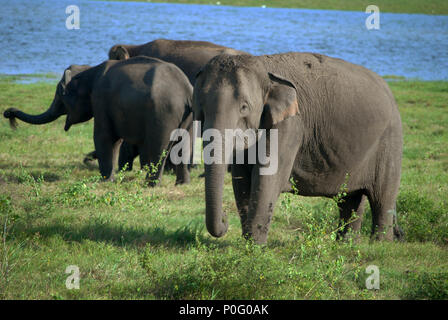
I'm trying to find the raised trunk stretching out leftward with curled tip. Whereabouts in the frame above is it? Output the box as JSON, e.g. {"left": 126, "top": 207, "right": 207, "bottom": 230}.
{"left": 3, "top": 97, "right": 65, "bottom": 128}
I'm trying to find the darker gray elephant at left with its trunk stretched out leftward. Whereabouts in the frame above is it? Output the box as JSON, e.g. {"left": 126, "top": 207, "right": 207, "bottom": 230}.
{"left": 4, "top": 57, "right": 193, "bottom": 185}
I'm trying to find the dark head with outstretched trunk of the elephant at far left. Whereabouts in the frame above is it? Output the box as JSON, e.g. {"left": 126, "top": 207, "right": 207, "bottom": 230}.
{"left": 3, "top": 65, "right": 91, "bottom": 131}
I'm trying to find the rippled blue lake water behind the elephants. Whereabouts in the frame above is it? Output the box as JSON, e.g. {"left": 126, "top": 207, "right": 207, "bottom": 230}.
{"left": 0, "top": 0, "right": 448, "bottom": 80}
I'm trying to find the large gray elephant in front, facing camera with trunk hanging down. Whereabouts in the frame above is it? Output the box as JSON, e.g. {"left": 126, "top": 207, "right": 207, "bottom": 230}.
{"left": 193, "top": 53, "right": 402, "bottom": 243}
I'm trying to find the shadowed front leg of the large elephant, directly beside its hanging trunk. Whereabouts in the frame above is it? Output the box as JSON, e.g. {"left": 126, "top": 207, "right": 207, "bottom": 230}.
{"left": 230, "top": 164, "right": 253, "bottom": 231}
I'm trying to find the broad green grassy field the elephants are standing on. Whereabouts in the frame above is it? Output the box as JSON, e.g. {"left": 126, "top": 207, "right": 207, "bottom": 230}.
{"left": 0, "top": 77, "right": 448, "bottom": 299}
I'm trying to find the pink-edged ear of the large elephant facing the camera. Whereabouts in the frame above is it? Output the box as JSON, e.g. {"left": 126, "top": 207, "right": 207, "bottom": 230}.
{"left": 260, "top": 73, "right": 299, "bottom": 129}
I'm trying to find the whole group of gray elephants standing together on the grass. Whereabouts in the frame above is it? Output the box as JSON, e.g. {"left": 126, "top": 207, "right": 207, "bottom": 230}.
{"left": 4, "top": 39, "right": 403, "bottom": 243}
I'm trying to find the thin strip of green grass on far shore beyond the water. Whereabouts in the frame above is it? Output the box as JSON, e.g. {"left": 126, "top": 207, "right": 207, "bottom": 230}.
{"left": 101, "top": 0, "right": 448, "bottom": 15}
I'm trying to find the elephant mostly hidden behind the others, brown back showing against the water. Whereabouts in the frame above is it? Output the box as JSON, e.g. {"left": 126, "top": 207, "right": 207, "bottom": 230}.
{"left": 80, "top": 39, "right": 249, "bottom": 170}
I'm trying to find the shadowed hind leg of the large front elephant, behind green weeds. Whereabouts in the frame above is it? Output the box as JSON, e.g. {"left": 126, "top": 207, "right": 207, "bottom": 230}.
{"left": 337, "top": 193, "right": 367, "bottom": 239}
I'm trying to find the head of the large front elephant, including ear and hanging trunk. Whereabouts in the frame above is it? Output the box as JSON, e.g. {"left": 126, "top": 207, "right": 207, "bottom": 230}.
{"left": 193, "top": 55, "right": 299, "bottom": 237}
